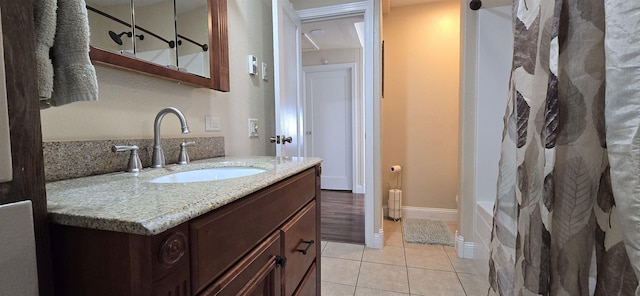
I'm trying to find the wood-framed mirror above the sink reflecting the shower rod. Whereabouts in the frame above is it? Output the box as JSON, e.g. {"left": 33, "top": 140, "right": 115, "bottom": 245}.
{"left": 86, "top": 0, "right": 229, "bottom": 91}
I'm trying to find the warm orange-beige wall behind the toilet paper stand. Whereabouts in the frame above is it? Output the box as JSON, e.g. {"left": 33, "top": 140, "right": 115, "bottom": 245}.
{"left": 382, "top": 1, "right": 460, "bottom": 209}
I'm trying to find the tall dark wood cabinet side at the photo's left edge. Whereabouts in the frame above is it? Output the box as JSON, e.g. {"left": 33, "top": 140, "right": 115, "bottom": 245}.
{"left": 0, "top": 0, "right": 53, "bottom": 296}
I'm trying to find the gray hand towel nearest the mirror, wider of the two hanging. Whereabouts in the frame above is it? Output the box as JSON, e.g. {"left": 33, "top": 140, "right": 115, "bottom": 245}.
{"left": 48, "top": 0, "right": 98, "bottom": 106}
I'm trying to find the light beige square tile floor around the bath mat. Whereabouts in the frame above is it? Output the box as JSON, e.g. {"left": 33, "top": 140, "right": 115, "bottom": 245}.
{"left": 321, "top": 220, "right": 489, "bottom": 296}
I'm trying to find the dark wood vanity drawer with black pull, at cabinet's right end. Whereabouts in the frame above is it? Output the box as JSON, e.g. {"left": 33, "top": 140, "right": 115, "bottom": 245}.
{"left": 281, "top": 201, "right": 320, "bottom": 296}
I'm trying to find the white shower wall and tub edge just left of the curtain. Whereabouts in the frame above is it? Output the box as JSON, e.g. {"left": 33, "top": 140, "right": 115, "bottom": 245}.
{"left": 473, "top": 6, "right": 513, "bottom": 271}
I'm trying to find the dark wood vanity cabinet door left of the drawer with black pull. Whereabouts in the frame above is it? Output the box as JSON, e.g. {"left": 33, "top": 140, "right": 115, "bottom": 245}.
{"left": 200, "top": 232, "right": 282, "bottom": 296}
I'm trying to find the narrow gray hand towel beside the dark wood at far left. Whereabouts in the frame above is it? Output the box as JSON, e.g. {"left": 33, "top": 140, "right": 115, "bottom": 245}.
{"left": 32, "top": 0, "right": 57, "bottom": 100}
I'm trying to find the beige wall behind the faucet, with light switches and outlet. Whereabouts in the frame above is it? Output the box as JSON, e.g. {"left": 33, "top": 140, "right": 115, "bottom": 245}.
{"left": 41, "top": 0, "right": 275, "bottom": 155}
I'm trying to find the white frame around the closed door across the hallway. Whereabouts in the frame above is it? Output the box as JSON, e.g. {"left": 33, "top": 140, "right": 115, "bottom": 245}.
{"left": 301, "top": 63, "right": 365, "bottom": 193}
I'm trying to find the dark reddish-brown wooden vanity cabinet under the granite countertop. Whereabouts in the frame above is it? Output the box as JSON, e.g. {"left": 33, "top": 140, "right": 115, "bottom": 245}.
{"left": 51, "top": 166, "right": 320, "bottom": 296}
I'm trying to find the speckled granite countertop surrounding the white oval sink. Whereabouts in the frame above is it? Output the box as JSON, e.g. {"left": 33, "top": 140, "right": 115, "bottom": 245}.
{"left": 46, "top": 156, "right": 321, "bottom": 235}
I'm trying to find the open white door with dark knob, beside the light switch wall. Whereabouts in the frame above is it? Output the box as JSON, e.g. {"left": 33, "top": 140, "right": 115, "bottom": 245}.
{"left": 272, "top": 0, "right": 304, "bottom": 156}
